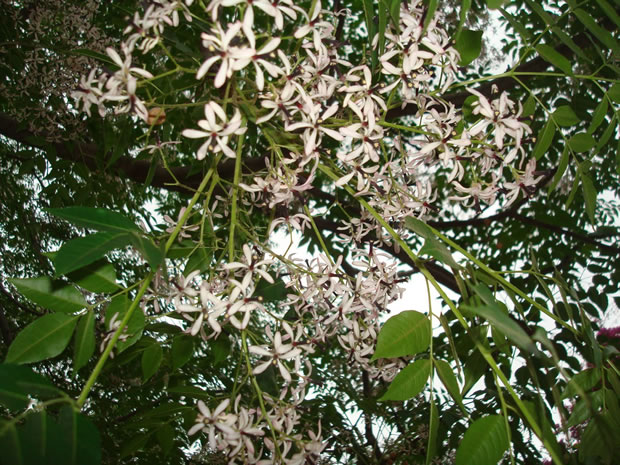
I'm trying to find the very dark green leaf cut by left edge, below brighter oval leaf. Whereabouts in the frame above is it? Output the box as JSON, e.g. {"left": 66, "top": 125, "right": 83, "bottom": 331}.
{"left": 0, "top": 363, "right": 60, "bottom": 411}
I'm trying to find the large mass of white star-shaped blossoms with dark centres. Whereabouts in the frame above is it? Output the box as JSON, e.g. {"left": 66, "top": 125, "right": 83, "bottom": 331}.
{"left": 75, "top": 0, "right": 541, "bottom": 464}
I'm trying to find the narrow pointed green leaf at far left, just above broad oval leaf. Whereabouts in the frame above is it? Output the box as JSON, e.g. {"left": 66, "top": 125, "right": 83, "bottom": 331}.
{"left": 9, "top": 276, "right": 88, "bottom": 313}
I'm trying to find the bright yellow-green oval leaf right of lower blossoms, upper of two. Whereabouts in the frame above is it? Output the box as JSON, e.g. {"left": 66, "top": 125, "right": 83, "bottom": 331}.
{"left": 371, "top": 310, "right": 431, "bottom": 361}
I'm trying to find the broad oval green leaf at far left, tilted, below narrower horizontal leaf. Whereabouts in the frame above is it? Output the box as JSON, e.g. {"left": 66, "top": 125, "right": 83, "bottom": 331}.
{"left": 5, "top": 313, "right": 78, "bottom": 364}
